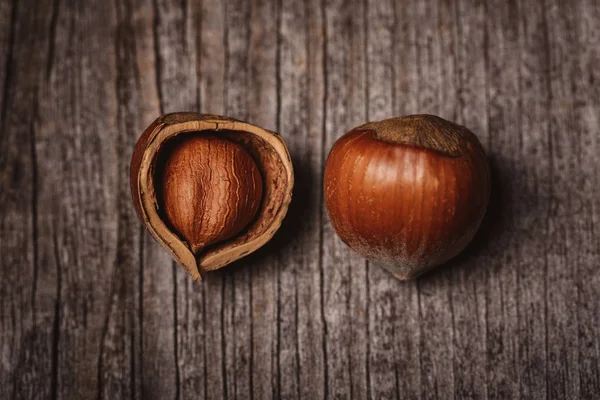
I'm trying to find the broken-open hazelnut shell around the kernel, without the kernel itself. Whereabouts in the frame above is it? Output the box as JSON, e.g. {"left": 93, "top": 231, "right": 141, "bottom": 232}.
{"left": 130, "top": 113, "right": 294, "bottom": 280}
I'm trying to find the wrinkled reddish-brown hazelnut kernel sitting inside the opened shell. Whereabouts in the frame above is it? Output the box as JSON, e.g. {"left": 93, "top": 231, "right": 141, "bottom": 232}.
{"left": 156, "top": 132, "right": 262, "bottom": 254}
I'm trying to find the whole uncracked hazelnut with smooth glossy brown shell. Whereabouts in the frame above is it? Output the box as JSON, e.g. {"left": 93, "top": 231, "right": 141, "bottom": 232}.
{"left": 324, "top": 115, "right": 490, "bottom": 279}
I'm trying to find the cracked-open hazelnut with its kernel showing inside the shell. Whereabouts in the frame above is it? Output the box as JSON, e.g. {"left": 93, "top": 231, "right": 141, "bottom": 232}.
{"left": 130, "top": 113, "right": 294, "bottom": 280}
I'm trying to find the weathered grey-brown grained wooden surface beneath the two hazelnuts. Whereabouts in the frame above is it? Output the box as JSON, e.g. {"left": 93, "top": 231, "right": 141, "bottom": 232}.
{"left": 0, "top": 0, "right": 600, "bottom": 399}
